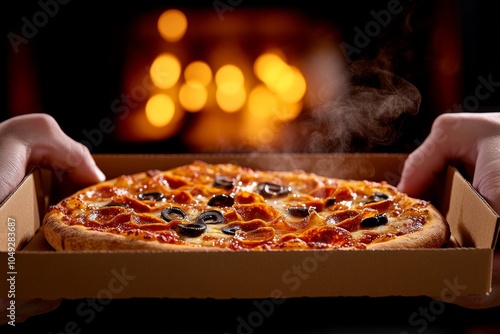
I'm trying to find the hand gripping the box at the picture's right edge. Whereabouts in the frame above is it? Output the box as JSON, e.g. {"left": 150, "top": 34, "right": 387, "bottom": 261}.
{"left": 398, "top": 113, "right": 500, "bottom": 308}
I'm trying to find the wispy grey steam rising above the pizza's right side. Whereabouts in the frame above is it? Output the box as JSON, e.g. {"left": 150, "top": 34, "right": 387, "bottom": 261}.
{"left": 282, "top": 61, "right": 421, "bottom": 153}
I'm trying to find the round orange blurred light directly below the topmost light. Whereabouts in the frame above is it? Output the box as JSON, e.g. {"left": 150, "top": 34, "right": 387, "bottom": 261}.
{"left": 149, "top": 53, "right": 181, "bottom": 89}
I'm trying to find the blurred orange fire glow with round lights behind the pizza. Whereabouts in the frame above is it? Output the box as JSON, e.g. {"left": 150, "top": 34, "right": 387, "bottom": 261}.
{"left": 117, "top": 9, "right": 340, "bottom": 151}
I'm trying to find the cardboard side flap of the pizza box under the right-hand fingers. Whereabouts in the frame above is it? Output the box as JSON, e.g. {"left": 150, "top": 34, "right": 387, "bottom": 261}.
{"left": 441, "top": 166, "right": 500, "bottom": 248}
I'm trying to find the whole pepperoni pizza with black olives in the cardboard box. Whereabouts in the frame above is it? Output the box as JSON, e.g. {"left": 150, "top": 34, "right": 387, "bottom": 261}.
{"left": 43, "top": 160, "right": 450, "bottom": 251}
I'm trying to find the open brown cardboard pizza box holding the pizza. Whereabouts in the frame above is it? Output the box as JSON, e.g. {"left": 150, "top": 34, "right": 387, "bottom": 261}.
{"left": 0, "top": 153, "right": 500, "bottom": 301}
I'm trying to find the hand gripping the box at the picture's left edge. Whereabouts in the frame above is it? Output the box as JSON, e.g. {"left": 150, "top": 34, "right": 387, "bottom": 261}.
{"left": 0, "top": 114, "right": 105, "bottom": 325}
